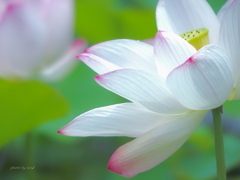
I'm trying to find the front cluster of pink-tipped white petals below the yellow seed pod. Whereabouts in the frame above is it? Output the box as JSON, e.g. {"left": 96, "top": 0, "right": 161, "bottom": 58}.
{"left": 58, "top": 26, "right": 234, "bottom": 177}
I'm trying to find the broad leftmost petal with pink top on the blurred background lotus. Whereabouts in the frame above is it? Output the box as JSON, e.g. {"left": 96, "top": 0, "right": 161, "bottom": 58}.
{"left": 0, "top": 3, "right": 46, "bottom": 78}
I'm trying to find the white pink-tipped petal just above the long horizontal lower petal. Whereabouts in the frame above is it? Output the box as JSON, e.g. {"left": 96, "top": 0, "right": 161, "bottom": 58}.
{"left": 95, "top": 69, "right": 189, "bottom": 114}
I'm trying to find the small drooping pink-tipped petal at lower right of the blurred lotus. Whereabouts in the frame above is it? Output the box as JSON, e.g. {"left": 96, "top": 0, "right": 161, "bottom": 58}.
{"left": 40, "top": 39, "right": 86, "bottom": 81}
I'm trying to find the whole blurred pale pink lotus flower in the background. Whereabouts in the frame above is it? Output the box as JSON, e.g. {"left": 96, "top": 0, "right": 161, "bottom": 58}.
{"left": 0, "top": 0, "right": 85, "bottom": 80}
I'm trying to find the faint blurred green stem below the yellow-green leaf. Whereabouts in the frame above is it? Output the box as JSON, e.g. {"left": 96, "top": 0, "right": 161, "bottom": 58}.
{"left": 25, "top": 132, "right": 36, "bottom": 180}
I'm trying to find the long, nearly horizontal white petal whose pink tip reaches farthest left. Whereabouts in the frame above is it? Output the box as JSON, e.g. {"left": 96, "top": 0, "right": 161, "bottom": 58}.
{"left": 58, "top": 103, "right": 174, "bottom": 137}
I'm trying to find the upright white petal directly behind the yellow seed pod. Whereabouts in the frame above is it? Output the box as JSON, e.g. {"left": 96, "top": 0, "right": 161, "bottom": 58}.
{"left": 156, "top": 0, "right": 219, "bottom": 43}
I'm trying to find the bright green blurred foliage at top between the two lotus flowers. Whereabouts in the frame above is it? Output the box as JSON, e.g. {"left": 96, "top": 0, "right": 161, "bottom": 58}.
{"left": 76, "top": 0, "right": 157, "bottom": 44}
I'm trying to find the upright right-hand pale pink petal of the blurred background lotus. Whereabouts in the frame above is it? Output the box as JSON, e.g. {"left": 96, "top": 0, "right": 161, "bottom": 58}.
{"left": 40, "top": 0, "right": 74, "bottom": 62}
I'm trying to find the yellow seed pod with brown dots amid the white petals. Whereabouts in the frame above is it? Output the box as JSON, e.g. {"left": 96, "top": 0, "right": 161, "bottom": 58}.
{"left": 180, "top": 28, "right": 209, "bottom": 50}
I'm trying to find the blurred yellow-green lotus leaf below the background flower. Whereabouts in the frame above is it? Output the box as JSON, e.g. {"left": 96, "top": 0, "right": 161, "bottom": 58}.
{"left": 0, "top": 79, "right": 68, "bottom": 147}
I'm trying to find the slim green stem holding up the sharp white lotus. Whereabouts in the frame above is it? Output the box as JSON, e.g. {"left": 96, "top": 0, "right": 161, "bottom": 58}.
{"left": 212, "top": 108, "right": 226, "bottom": 180}
